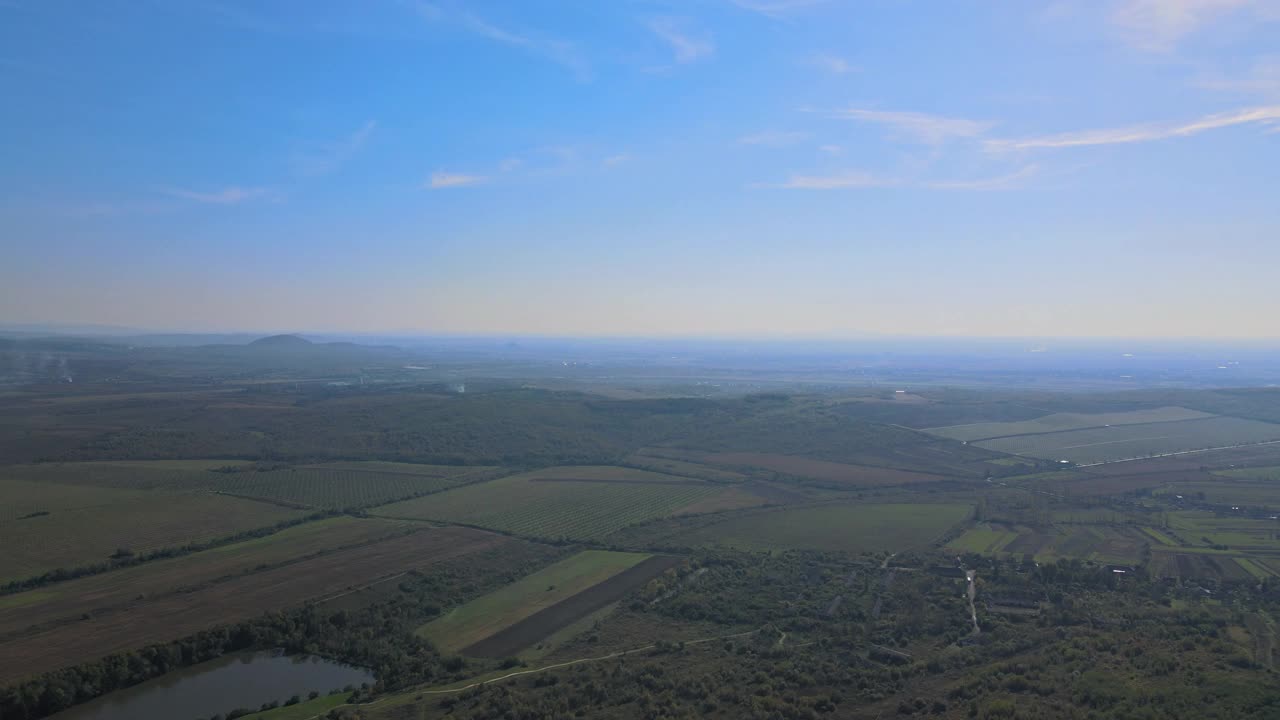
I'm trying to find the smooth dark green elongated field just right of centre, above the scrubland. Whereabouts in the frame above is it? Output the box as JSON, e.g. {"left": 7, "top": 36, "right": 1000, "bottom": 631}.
{"left": 672, "top": 503, "right": 973, "bottom": 552}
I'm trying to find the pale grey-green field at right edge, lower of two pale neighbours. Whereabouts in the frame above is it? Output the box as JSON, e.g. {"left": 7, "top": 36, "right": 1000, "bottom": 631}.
{"left": 974, "top": 418, "right": 1280, "bottom": 465}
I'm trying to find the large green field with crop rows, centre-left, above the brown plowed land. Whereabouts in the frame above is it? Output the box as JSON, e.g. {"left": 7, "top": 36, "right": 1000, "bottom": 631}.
{"left": 374, "top": 468, "right": 724, "bottom": 541}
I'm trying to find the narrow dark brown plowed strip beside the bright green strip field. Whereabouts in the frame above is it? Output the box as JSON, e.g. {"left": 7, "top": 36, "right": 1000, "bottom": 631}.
{"left": 461, "top": 555, "right": 680, "bottom": 657}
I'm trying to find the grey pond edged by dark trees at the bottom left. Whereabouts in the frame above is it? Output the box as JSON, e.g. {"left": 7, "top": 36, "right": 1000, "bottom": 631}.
{"left": 52, "top": 651, "right": 374, "bottom": 720}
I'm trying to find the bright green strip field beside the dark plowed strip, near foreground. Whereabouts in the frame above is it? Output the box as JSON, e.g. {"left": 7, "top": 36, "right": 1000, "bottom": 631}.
{"left": 417, "top": 550, "right": 649, "bottom": 652}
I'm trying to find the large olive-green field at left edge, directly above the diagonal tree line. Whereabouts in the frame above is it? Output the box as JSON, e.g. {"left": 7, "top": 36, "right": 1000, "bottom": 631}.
{"left": 0, "top": 493, "right": 306, "bottom": 582}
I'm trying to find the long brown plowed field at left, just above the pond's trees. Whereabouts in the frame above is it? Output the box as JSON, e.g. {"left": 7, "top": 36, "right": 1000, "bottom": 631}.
{"left": 0, "top": 528, "right": 517, "bottom": 685}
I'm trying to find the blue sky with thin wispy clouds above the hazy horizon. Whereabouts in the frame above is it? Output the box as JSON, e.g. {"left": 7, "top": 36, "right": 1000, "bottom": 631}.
{"left": 0, "top": 0, "right": 1280, "bottom": 338}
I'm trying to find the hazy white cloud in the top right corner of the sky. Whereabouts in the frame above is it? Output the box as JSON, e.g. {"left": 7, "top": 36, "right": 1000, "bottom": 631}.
{"left": 1110, "top": 0, "right": 1280, "bottom": 53}
